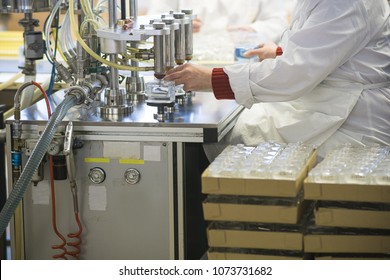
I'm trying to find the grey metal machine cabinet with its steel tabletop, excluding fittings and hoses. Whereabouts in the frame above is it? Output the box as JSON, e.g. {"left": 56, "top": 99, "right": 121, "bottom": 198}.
{"left": 6, "top": 92, "right": 242, "bottom": 259}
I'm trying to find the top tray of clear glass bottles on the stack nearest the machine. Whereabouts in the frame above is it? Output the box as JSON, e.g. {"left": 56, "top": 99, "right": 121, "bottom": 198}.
{"left": 202, "top": 142, "right": 316, "bottom": 197}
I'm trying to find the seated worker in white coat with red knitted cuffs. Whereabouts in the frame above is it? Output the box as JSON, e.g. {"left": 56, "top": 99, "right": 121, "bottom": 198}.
{"left": 166, "top": 0, "right": 390, "bottom": 156}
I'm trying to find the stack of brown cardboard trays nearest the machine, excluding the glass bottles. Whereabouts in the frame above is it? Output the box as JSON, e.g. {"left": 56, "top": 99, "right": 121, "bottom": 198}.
{"left": 202, "top": 143, "right": 316, "bottom": 259}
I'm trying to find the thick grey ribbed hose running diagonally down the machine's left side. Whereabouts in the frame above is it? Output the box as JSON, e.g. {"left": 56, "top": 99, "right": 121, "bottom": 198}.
{"left": 0, "top": 95, "right": 78, "bottom": 235}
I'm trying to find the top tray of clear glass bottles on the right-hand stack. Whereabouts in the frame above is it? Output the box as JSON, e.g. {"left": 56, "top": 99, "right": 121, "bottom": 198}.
{"left": 304, "top": 144, "right": 390, "bottom": 203}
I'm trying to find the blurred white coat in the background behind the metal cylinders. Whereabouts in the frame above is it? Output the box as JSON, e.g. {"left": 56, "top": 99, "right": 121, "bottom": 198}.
{"left": 148, "top": 0, "right": 287, "bottom": 41}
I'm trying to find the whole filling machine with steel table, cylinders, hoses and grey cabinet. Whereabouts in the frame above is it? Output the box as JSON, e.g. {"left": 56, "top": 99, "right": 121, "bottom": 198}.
{"left": 0, "top": 0, "right": 242, "bottom": 259}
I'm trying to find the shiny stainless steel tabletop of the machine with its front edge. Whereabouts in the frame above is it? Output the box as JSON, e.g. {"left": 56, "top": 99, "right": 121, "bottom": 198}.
{"left": 7, "top": 90, "right": 243, "bottom": 143}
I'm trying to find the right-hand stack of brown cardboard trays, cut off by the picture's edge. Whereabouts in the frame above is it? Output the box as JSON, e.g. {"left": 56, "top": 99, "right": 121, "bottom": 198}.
{"left": 304, "top": 145, "right": 390, "bottom": 259}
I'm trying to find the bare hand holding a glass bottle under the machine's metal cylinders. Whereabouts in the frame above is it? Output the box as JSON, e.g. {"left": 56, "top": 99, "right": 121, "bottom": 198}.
{"left": 164, "top": 63, "right": 213, "bottom": 91}
